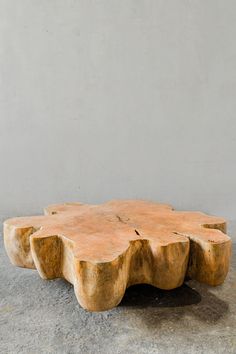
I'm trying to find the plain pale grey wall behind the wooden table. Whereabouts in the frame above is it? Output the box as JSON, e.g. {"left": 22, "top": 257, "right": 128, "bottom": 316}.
{"left": 0, "top": 0, "right": 236, "bottom": 218}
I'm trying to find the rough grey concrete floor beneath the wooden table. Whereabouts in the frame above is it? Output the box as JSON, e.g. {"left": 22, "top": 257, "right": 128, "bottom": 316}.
{"left": 0, "top": 222, "right": 236, "bottom": 354}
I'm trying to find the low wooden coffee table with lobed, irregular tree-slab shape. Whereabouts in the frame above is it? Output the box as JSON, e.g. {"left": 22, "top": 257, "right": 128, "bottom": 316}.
{"left": 4, "top": 200, "right": 231, "bottom": 311}
